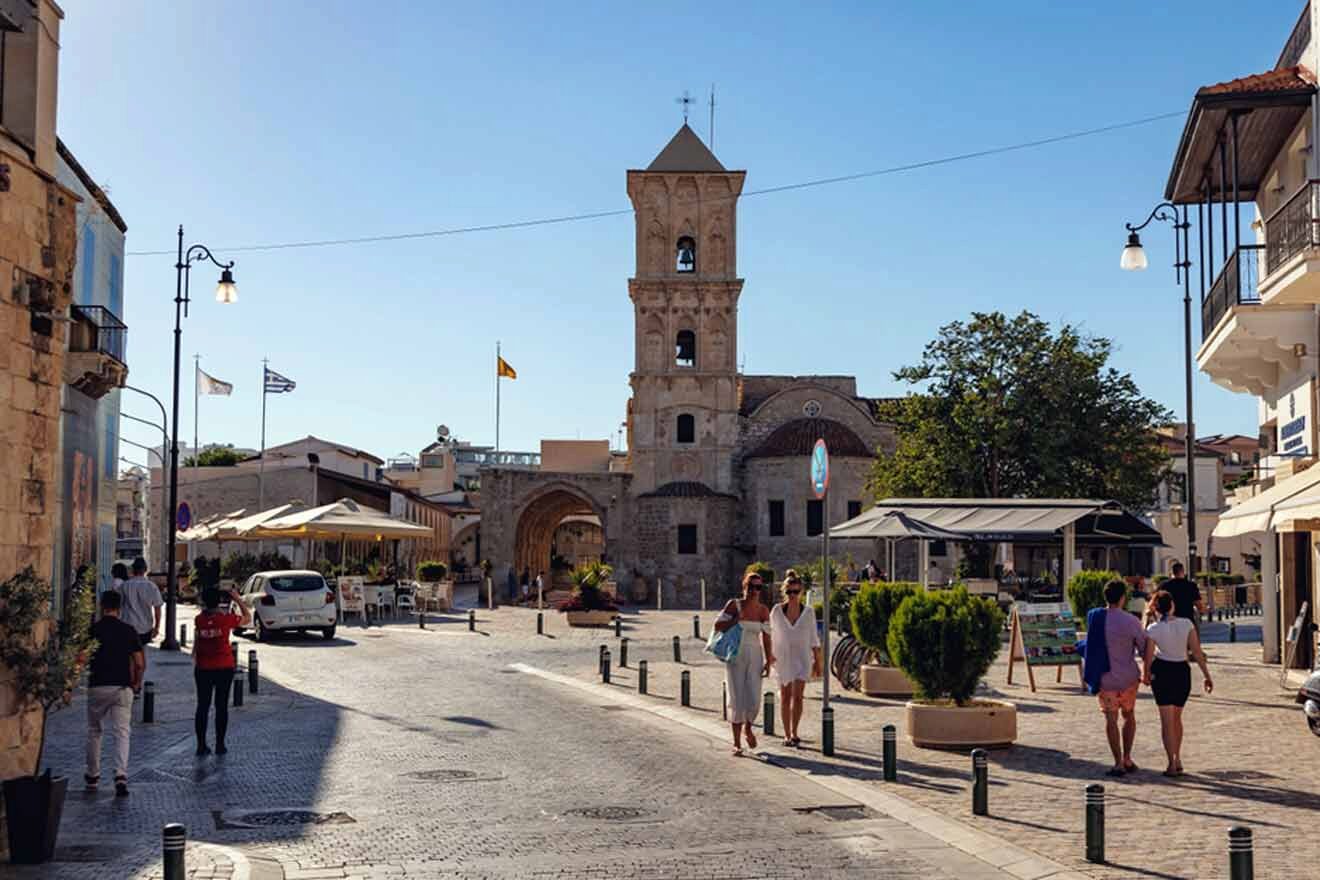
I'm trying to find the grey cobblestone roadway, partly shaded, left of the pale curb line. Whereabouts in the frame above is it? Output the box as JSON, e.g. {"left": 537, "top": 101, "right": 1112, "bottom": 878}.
{"left": 15, "top": 598, "right": 1034, "bottom": 880}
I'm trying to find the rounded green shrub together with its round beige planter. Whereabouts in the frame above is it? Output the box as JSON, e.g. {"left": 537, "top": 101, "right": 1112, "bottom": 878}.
{"left": 888, "top": 587, "right": 1018, "bottom": 748}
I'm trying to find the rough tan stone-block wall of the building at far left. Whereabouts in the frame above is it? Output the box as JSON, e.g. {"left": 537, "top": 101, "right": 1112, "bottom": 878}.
{"left": 0, "top": 145, "right": 77, "bottom": 778}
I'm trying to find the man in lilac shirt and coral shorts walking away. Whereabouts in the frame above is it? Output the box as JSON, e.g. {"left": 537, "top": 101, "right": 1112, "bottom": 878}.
{"left": 1082, "top": 581, "right": 1146, "bottom": 776}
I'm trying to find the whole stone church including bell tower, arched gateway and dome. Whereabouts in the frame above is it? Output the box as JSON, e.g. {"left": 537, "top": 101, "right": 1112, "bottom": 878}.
{"left": 482, "top": 125, "right": 894, "bottom": 604}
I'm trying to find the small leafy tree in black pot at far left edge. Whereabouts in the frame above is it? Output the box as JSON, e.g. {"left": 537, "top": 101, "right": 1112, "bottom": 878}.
{"left": 0, "top": 567, "right": 96, "bottom": 864}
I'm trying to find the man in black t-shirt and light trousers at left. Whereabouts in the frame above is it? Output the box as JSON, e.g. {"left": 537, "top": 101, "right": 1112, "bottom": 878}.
{"left": 83, "top": 590, "right": 147, "bottom": 797}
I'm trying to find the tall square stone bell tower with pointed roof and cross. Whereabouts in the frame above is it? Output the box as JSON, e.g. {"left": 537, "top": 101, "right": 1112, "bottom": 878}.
{"left": 628, "top": 123, "right": 746, "bottom": 493}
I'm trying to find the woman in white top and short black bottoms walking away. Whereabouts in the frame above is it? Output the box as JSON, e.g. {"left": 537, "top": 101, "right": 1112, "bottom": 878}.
{"left": 1142, "top": 590, "right": 1214, "bottom": 776}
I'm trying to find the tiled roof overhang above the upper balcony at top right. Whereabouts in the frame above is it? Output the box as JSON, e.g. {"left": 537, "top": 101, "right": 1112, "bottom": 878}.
{"left": 1164, "top": 65, "right": 1316, "bottom": 204}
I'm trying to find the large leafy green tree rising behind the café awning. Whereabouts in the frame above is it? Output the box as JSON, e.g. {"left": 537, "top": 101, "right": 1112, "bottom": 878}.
{"left": 869, "top": 311, "right": 1172, "bottom": 507}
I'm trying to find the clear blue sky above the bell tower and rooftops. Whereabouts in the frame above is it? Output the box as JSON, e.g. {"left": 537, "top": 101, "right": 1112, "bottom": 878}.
{"left": 59, "top": 0, "right": 1302, "bottom": 467}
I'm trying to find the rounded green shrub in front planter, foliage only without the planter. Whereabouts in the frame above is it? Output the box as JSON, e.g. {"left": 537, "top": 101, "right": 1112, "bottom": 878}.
{"left": 888, "top": 587, "right": 1003, "bottom": 706}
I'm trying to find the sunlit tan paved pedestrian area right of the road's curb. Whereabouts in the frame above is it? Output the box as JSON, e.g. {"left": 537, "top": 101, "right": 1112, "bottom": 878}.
{"left": 480, "top": 608, "right": 1320, "bottom": 880}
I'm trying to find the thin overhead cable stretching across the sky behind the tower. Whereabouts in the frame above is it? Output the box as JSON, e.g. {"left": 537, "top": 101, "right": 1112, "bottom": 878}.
{"left": 127, "top": 111, "right": 1185, "bottom": 257}
